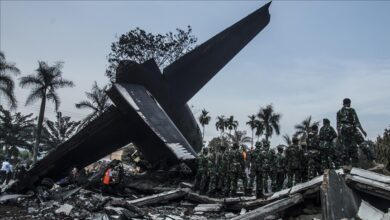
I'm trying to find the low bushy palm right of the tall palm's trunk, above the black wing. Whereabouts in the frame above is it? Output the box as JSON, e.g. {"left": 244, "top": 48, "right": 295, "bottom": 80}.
{"left": 44, "top": 112, "right": 80, "bottom": 151}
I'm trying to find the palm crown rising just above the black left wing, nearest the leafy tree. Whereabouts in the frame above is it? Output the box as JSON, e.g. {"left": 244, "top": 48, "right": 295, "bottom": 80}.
{"left": 76, "top": 81, "right": 110, "bottom": 125}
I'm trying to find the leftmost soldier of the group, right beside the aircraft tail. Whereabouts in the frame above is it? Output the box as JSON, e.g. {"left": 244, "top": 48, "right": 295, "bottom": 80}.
{"left": 194, "top": 148, "right": 208, "bottom": 193}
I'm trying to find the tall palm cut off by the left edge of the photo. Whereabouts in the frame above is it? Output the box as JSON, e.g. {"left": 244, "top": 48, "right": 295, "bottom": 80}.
{"left": 0, "top": 51, "right": 20, "bottom": 109}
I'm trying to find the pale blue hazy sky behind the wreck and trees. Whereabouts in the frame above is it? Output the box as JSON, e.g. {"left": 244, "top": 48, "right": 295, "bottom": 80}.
{"left": 0, "top": 0, "right": 390, "bottom": 146}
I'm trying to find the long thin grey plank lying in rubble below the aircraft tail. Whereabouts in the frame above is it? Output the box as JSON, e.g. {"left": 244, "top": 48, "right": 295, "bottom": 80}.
{"left": 128, "top": 189, "right": 189, "bottom": 206}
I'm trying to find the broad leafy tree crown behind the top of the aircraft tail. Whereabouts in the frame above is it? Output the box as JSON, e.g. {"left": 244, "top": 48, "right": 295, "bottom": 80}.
{"left": 106, "top": 26, "right": 197, "bottom": 82}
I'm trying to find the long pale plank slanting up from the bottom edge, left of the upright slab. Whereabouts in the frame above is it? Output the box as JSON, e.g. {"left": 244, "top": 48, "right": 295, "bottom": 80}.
{"left": 232, "top": 194, "right": 303, "bottom": 220}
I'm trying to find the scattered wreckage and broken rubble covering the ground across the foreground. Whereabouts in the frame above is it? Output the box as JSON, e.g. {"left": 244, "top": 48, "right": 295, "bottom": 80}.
{"left": 0, "top": 168, "right": 390, "bottom": 220}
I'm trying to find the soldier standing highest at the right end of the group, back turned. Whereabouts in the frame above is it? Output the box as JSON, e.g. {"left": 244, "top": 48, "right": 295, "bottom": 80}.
{"left": 337, "top": 98, "right": 367, "bottom": 166}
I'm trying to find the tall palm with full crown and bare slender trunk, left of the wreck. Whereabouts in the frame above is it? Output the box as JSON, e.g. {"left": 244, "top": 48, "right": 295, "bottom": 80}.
{"left": 19, "top": 61, "right": 74, "bottom": 163}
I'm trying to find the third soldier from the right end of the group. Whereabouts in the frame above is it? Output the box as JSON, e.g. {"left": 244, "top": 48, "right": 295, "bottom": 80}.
{"left": 307, "top": 125, "right": 323, "bottom": 180}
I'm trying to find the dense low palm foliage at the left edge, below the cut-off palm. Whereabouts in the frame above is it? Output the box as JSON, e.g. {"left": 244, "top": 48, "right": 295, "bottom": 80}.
{"left": 0, "top": 106, "right": 35, "bottom": 158}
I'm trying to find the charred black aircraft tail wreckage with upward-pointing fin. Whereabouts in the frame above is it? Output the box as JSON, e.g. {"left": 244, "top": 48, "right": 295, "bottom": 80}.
{"left": 18, "top": 3, "right": 271, "bottom": 190}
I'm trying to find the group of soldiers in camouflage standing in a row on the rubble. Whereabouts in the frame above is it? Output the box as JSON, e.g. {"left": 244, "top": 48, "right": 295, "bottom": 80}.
{"left": 194, "top": 98, "right": 372, "bottom": 198}
